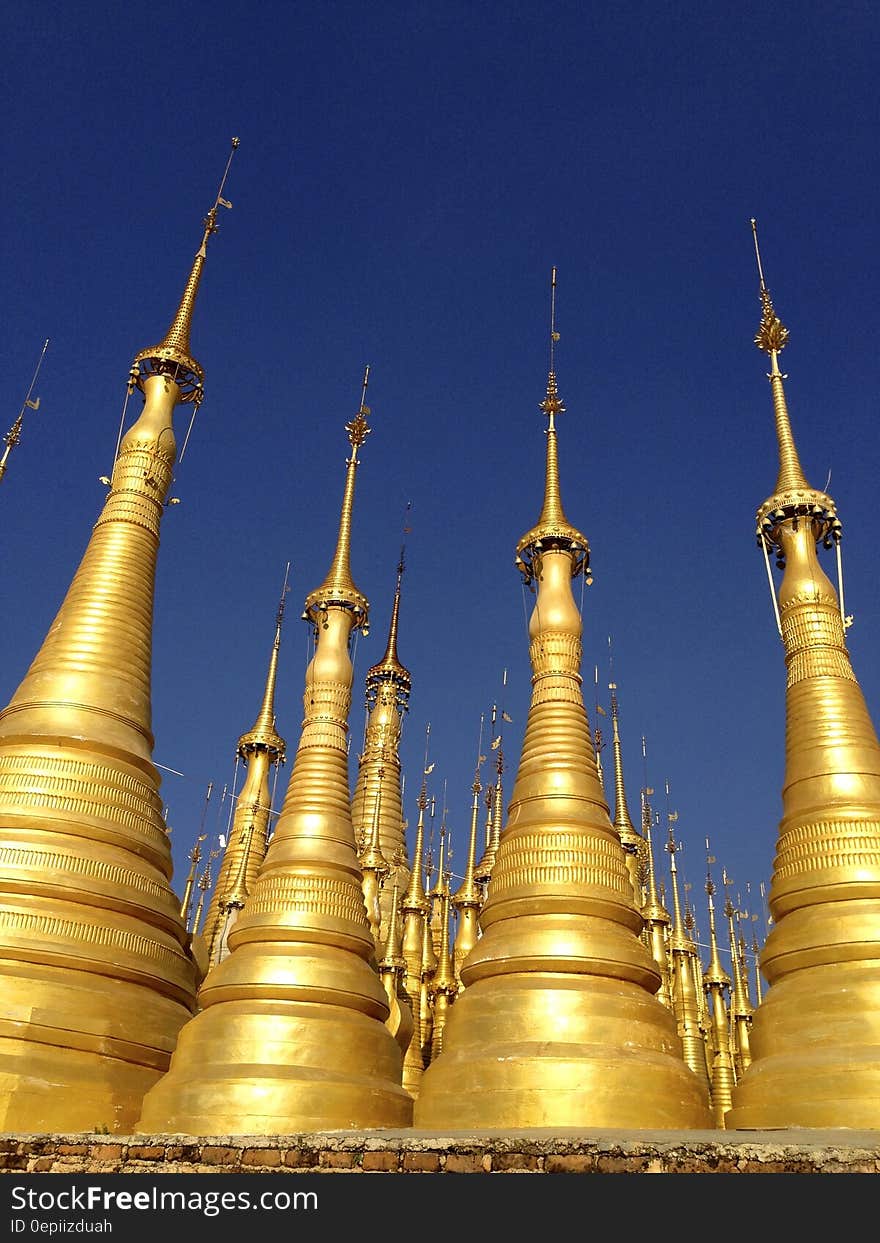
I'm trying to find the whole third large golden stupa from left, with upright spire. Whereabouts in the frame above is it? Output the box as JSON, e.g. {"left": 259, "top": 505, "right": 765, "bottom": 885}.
{"left": 414, "top": 277, "right": 711, "bottom": 1129}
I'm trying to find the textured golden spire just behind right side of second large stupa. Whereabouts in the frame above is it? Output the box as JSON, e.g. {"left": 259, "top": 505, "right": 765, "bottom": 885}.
{"left": 352, "top": 527, "right": 411, "bottom": 943}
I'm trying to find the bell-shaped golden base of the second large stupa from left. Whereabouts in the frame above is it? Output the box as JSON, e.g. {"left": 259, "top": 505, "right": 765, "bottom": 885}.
{"left": 137, "top": 943, "right": 413, "bottom": 1135}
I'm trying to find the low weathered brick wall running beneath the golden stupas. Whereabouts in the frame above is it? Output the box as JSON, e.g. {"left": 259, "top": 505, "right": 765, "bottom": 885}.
{"left": 0, "top": 1130, "right": 880, "bottom": 1175}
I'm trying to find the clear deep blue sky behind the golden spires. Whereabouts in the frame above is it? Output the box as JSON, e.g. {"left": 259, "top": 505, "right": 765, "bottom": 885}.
{"left": 0, "top": 0, "right": 880, "bottom": 939}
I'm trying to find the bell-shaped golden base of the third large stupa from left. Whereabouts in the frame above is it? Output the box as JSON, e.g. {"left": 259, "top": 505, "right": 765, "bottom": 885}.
{"left": 414, "top": 915, "right": 713, "bottom": 1129}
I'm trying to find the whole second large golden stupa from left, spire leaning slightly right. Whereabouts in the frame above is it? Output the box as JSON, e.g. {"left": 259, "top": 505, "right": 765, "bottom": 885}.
{"left": 138, "top": 370, "right": 413, "bottom": 1135}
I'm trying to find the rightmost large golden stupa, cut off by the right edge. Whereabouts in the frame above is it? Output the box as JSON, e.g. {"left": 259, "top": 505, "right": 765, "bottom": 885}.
{"left": 727, "top": 221, "right": 880, "bottom": 1127}
